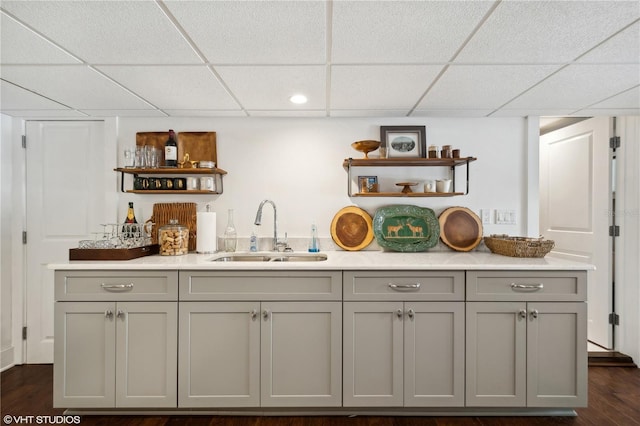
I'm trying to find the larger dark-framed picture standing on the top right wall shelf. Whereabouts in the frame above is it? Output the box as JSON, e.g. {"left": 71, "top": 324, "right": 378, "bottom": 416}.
{"left": 380, "top": 126, "right": 427, "bottom": 158}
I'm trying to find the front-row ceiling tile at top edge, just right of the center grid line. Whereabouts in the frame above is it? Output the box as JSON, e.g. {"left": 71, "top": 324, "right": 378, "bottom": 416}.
{"left": 331, "top": 1, "right": 493, "bottom": 64}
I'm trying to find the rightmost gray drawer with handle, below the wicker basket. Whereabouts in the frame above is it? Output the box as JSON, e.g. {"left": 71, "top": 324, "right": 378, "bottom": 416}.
{"left": 467, "top": 271, "right": 587, "bottom": 302}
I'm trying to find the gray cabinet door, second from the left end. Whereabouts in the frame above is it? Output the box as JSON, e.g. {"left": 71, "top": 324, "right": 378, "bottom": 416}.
{"left": 115, "top": 302, "right": 178, "bottom": 407}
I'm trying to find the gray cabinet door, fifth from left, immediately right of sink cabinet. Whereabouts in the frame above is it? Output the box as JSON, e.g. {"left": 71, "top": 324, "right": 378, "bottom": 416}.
{"left": 343, "top": 302, "right": 404, "bottom": 407}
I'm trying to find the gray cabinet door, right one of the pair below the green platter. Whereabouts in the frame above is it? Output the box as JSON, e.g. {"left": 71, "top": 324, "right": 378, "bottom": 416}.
{"left": 404, "top": 302, "right": 465, "bottom": 407}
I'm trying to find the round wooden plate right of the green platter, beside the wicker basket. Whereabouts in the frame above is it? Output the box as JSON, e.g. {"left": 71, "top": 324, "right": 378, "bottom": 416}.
{"left": 438, "top": 207, "right": 482, "bottom": 251}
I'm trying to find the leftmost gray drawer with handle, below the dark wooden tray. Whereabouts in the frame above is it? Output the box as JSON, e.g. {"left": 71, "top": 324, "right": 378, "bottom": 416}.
{"left": 54, "top": 270, "right": 178, "bottom": 301}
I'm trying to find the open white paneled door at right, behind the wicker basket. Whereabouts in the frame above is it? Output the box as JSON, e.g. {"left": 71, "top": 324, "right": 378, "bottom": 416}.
{"left": 540, "top": 117, "right": 612, "bottom": 347}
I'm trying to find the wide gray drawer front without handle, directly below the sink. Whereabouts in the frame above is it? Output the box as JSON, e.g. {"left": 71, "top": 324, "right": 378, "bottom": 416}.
{"left": 180, "top": 271, "right": 342, "bottom": 300}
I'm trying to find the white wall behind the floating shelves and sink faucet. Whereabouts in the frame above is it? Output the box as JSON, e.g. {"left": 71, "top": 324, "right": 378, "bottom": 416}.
{"left": 114, "top": 118, "right": 527, "bottom": 246}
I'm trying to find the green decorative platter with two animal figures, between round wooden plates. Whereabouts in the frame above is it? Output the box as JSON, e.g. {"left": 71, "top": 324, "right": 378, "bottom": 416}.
{"left": 373, "top": 205, "right": 440, "bottom": 252}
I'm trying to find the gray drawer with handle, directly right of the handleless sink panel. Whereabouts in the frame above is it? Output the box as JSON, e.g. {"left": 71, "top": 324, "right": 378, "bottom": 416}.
{"left": 344, "top": 271, "right": 464, "bottom": 301}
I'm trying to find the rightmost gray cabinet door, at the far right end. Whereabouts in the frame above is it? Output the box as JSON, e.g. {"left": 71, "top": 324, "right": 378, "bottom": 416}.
{"left": 527, "top": 302, "right": 587, "bottom": 407}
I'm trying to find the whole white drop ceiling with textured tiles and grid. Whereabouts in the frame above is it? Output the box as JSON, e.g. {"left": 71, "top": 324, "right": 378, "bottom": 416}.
{"left": 0, "top": 0, "right": 640, "bottom": 118}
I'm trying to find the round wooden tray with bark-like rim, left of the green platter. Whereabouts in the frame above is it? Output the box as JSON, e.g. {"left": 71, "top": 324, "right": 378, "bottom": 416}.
{"left": 331, "top": 206, "right": 373, "bottom": 251}
